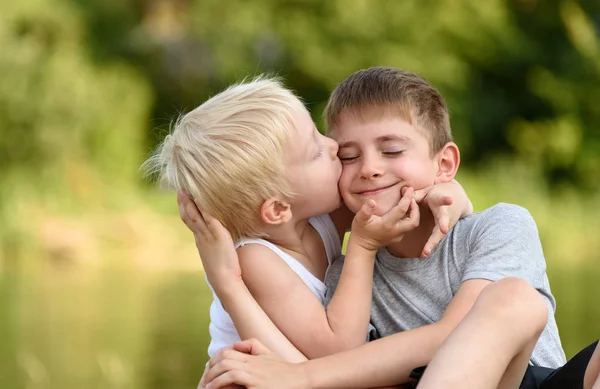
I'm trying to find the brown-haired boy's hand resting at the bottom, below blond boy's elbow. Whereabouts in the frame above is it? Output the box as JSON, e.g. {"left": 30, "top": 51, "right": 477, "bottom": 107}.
{"left": 201, "top": 339, "right": 310, "bottom": 389}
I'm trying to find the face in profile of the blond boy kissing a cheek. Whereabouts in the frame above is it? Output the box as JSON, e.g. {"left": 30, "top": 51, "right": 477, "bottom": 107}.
{"left": 285, "top": 109, "right": 342, "bottom": 219}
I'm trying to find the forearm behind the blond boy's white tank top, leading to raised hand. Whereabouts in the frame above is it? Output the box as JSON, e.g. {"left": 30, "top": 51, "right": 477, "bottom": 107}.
{"left": 217, "top": 282, "right": 306, "bottom": 362}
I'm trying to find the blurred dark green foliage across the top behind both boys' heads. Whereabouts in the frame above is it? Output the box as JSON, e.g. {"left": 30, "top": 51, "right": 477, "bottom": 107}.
{"left": 65, "top": 0, "right": 600, "bottom": 188}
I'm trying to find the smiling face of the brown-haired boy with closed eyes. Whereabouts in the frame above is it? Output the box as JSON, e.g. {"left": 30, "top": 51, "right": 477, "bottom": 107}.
{"left": 331, "top": 115, "right": 438, "bottom": 215}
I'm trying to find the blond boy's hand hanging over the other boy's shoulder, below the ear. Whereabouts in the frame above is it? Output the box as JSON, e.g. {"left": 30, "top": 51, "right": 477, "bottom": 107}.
{"left": 415, "top": 181, "right": 472, "bottom": 257}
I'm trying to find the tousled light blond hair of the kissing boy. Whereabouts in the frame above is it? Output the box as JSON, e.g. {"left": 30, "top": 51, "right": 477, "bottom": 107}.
{"left": 143, "top": 77, "right": 304, "bottom": 242}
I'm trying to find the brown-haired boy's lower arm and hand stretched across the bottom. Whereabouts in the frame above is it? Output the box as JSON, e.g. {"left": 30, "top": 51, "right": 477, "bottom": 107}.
{"left": 205, "top": 280, "right": 490, "bottom": 389}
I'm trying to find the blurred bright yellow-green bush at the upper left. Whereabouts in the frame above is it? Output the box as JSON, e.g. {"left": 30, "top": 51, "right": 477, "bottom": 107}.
{"left": 0, "top": 0, "right": 152, "bottom": 193}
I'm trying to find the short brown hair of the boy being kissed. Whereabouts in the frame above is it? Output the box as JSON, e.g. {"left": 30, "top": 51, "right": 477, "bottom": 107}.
{"left": 324, "top": 67, "right": 452, "bottom": 155}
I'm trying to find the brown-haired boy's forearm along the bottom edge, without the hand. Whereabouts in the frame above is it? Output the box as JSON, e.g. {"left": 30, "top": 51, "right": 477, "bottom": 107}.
{"left": 302, "top": 322, "right": 454, "bottom": 389}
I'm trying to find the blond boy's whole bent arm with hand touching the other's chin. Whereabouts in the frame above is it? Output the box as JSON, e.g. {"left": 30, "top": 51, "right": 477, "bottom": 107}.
{"left": 238, "top": 193, "right": 418, "bottom": 359}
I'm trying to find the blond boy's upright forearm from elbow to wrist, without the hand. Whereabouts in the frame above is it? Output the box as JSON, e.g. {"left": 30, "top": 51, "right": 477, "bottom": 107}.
{"left": 327, "top": 241, "right": 375, "bottom": 352}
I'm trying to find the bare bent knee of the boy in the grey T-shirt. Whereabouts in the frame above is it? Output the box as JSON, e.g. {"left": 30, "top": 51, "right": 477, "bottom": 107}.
{"left": 481, "top": 277, "right": 548, "bottom": 332}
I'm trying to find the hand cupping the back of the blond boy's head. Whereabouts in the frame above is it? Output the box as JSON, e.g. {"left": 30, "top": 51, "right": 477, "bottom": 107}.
{"left": 177, "top": 192, "right": 242, "bottom": 287}
